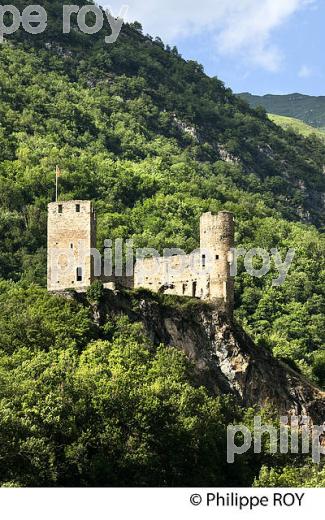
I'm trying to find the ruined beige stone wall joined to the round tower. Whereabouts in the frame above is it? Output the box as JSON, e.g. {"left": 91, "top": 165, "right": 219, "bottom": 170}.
{"left": 134, "top": 212, "right": 234, "bottom": 312}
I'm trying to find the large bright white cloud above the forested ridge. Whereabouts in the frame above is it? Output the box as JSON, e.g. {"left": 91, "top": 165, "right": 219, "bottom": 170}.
{"left": 104, "top": 0, "right": 315, "bottom": 71}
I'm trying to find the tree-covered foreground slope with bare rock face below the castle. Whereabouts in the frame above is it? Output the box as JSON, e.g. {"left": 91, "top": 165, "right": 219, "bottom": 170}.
{"left": 0, "top": 282, "right": 324, "bottom": 487}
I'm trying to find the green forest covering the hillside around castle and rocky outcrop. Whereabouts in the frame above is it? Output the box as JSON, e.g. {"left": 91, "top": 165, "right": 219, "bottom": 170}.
{"left": 0, "top": 1, "right": 325, "bottom": 486}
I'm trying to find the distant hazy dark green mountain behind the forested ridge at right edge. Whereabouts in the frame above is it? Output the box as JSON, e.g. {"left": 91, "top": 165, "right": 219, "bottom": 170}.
{"left": 238, "top": 92, "right": 325, "bottom": 128}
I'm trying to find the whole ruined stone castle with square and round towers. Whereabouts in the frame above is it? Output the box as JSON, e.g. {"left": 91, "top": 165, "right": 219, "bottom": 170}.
{"left": 47, "top": 200, "right": 234, "bottom": 313}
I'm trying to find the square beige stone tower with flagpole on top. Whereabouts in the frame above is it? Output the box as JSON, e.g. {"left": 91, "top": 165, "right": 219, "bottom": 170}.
{"left": 47, "top": 200, "right": 96, "bottom": 291}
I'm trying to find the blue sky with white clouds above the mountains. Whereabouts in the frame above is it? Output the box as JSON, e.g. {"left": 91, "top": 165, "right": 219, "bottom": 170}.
{"left": 104, "top": 0, "right": 325, "bottom": 96}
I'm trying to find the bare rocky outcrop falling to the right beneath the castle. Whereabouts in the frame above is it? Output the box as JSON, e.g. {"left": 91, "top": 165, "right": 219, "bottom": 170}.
{"left": 83, "top": 291, "right": 325, "bottom": 423}
